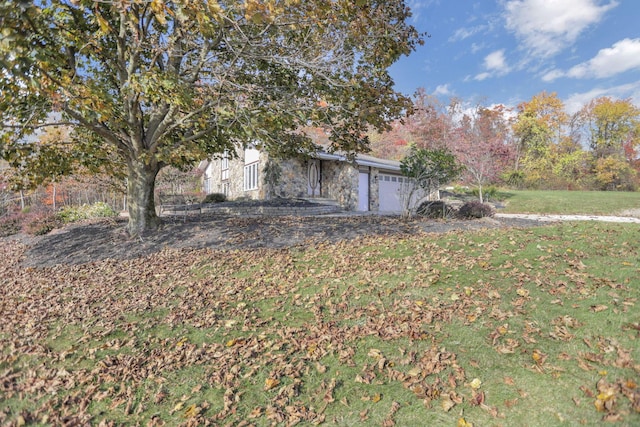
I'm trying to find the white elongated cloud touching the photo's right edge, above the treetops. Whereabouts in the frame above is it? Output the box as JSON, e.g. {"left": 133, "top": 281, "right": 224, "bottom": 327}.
{"left": 567, "top": 38, "right": 640, "bottom": 78}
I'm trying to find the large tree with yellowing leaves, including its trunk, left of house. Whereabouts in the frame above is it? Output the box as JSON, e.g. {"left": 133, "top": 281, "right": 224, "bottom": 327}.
{"left": 0, "top": 0, "right": 422, "bottom": 235}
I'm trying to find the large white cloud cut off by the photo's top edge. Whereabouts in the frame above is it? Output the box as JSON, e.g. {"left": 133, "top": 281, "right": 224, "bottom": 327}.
{"left": 504, "top": 0, "right": 618, "bottom": 57}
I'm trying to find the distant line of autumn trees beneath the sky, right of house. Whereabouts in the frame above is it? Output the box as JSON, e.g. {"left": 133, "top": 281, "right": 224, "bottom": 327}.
{"left": 370, "top": 90, "right": 640, "bottom": 193}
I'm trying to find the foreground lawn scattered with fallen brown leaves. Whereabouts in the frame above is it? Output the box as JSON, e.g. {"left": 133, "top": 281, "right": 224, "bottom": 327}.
{"left": 0, "top": 223, "right": 640, "bottom": 426}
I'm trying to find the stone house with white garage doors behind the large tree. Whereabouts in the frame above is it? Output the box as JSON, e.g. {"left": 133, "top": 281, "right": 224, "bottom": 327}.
{"left": 200, "top": 148, "right": 418, "bottom": 213}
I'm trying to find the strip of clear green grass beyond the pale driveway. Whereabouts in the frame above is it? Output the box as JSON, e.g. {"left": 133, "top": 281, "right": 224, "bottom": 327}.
{"left": 499, "top": 190, "right": 640, "bottom": 215}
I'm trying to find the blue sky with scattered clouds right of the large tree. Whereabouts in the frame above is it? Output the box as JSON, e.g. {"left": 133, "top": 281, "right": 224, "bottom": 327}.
{"left": 390, "top": 0, "right": 640, "bottom": 113}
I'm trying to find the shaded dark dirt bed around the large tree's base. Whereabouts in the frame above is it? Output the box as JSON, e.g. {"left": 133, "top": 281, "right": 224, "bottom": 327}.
{"left": 0, "top": 215, "right": 544, "bottom": 267}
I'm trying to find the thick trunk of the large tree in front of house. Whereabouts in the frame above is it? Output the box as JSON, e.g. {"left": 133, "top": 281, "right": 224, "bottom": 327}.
{"left": 127, "top": 161, "right": 160, "bottom": 236}
